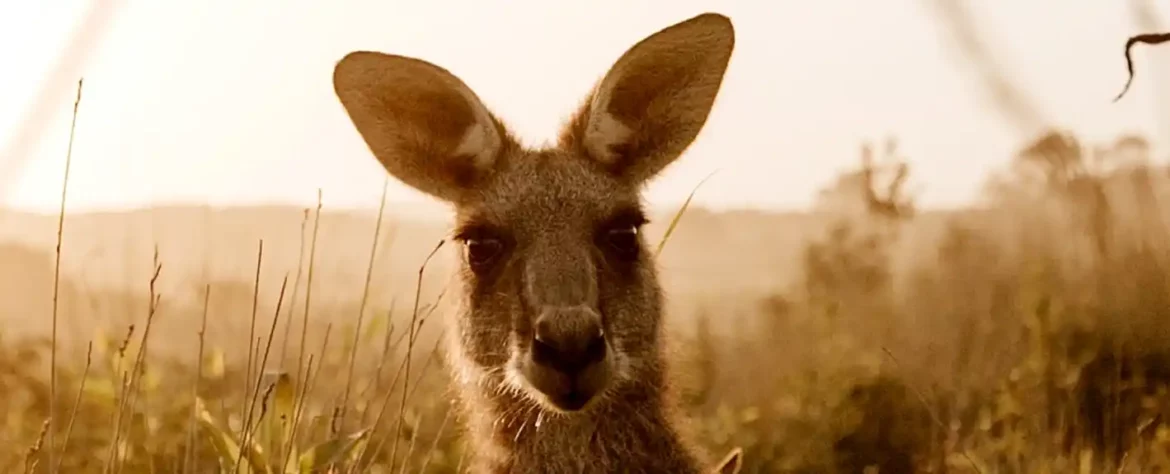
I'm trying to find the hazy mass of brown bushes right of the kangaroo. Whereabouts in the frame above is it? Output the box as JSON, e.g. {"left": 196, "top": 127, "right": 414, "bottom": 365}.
{"left": 693, "top": 131, "right": 1170, "bottom": 473}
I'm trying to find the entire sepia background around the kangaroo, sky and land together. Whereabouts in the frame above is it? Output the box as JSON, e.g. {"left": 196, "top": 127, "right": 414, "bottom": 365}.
{"left": 0, "top": 0, "right": 1170, "bottom": 473}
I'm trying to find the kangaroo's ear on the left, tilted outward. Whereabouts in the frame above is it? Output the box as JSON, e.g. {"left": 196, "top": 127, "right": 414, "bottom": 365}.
{"left": 333, "top": 51, "right": 510, "bottom": 201}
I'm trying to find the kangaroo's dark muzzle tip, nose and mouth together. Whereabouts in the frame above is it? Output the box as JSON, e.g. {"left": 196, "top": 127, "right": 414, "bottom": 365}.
{"left": 524, "top": 305, "right": 610, "bottom": 411}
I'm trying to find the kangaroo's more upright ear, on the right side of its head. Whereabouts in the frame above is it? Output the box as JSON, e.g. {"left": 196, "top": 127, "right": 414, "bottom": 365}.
{"left": 560, "top": 13, "right": 735, "bottom": 184}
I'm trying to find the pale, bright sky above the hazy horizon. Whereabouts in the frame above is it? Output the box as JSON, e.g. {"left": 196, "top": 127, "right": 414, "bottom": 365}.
{"left": 0, "top": 0, "right": 1170, "bottom": 215}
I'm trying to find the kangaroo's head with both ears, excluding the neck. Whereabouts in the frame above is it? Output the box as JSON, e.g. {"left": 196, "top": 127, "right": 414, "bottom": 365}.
{"left": 333, "top": 14, "right": 735, "bottom": 413}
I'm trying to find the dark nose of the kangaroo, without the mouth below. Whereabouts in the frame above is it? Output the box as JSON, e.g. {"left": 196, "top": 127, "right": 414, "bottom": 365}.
{"left": 532, "top": 307, "right": 605, "bottom": 375}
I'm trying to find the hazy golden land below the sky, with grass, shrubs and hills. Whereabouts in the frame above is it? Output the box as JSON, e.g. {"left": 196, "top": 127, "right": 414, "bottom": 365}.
{"left": 0, "top": 132, "right": 1170, "bottom": 473}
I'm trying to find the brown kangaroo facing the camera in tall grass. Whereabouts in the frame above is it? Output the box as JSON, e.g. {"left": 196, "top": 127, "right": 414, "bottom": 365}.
{"left": 333, "top": 13, "right": 739, "bottom": 474}
